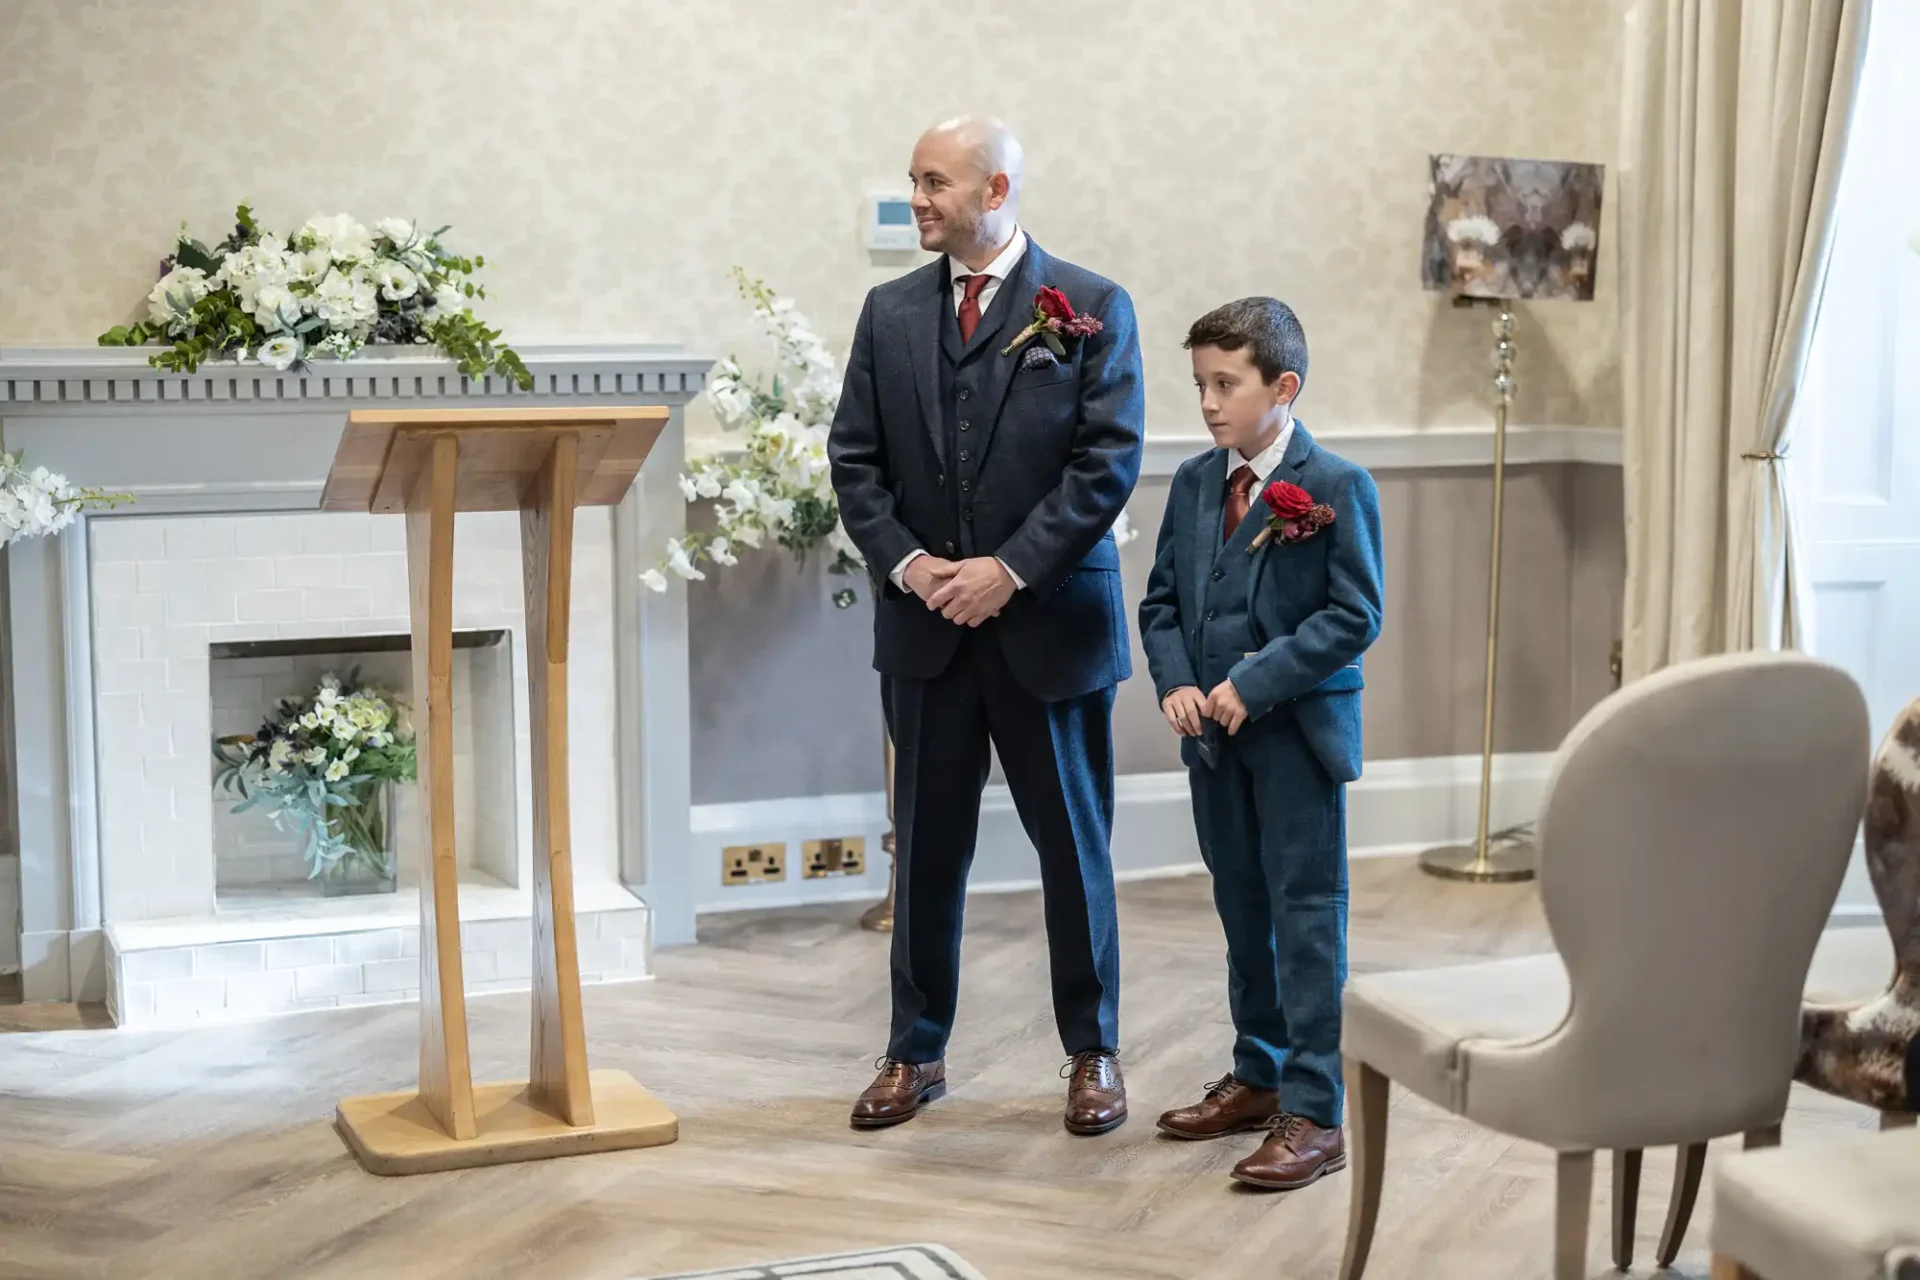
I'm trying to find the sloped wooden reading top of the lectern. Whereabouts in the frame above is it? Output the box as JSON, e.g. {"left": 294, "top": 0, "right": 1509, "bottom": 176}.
{"left": 321, "top": 405, "right": 670, "bottom": 514}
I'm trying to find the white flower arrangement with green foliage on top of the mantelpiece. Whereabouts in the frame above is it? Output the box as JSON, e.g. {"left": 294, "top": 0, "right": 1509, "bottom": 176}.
{"left": 100, "top": 205, "right": 534, "bottom": 390}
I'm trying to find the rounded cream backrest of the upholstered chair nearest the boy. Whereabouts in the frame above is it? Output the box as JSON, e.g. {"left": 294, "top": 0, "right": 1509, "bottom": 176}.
{"left": 1538, "top": 652, "right": 1870, "bottom": 1146}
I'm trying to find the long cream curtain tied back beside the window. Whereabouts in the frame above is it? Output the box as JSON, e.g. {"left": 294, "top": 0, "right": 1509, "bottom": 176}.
{"left": 1619, "top": 0, "right": 1873, "bottom": 679}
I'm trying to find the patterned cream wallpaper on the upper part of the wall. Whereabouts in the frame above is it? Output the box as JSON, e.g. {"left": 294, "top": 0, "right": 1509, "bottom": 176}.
{"left": 0, "top": 0, "right": 1620, "bottom": 434}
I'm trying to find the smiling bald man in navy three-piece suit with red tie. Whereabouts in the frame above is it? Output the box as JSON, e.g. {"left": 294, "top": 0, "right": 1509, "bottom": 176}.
{"left": 829, "top": 117, "right": 1144, "bottom": 1134}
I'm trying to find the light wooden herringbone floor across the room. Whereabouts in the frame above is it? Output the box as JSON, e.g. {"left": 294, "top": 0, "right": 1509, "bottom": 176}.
{"left": 0, "top": 862, "right": 1870, "bottom": 1280}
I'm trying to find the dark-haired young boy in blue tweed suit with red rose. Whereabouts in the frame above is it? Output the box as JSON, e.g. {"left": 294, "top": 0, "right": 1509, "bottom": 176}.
{"left": 1140, "top": 297, "right": 1380, "bottom": 1190}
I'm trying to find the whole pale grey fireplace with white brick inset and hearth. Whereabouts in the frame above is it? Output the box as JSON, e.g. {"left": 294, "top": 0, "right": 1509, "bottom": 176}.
{"left": 0, "top": 344, "right": 708, "bottom": 1025}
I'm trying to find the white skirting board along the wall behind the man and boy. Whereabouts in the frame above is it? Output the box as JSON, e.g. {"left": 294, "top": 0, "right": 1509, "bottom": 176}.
{"left": 691, "top": 752, "right": 1553, "bottom": 912}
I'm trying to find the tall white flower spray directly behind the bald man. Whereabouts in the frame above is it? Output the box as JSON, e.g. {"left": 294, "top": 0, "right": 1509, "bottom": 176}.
{"left": 639, "top": 267, "right": 1135, "bottom": 608}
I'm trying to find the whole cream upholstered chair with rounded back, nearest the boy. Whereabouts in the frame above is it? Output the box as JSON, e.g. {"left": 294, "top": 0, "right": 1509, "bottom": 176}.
{"left": 1340, "top": 652, "right": 1868, "bottom": 1280}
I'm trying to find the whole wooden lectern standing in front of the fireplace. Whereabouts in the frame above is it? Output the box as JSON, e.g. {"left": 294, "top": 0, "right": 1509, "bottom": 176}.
{"left": 321, "top": 407, "right": 680, "bottom": 1174}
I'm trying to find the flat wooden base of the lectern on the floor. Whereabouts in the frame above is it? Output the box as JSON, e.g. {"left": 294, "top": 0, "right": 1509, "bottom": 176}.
{"left": 334, "top": 1071, "right": 680, "bottom": 1176}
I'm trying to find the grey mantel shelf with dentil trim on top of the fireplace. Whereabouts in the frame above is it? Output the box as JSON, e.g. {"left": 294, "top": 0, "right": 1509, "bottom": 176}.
{"left": 0, "top": 342, "right": 712, "bottom": 413}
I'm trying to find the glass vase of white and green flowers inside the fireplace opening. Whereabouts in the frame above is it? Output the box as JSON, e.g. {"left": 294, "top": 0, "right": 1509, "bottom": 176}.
{"left": 213, "top": 670, "right": 415, "bottom": 887}
